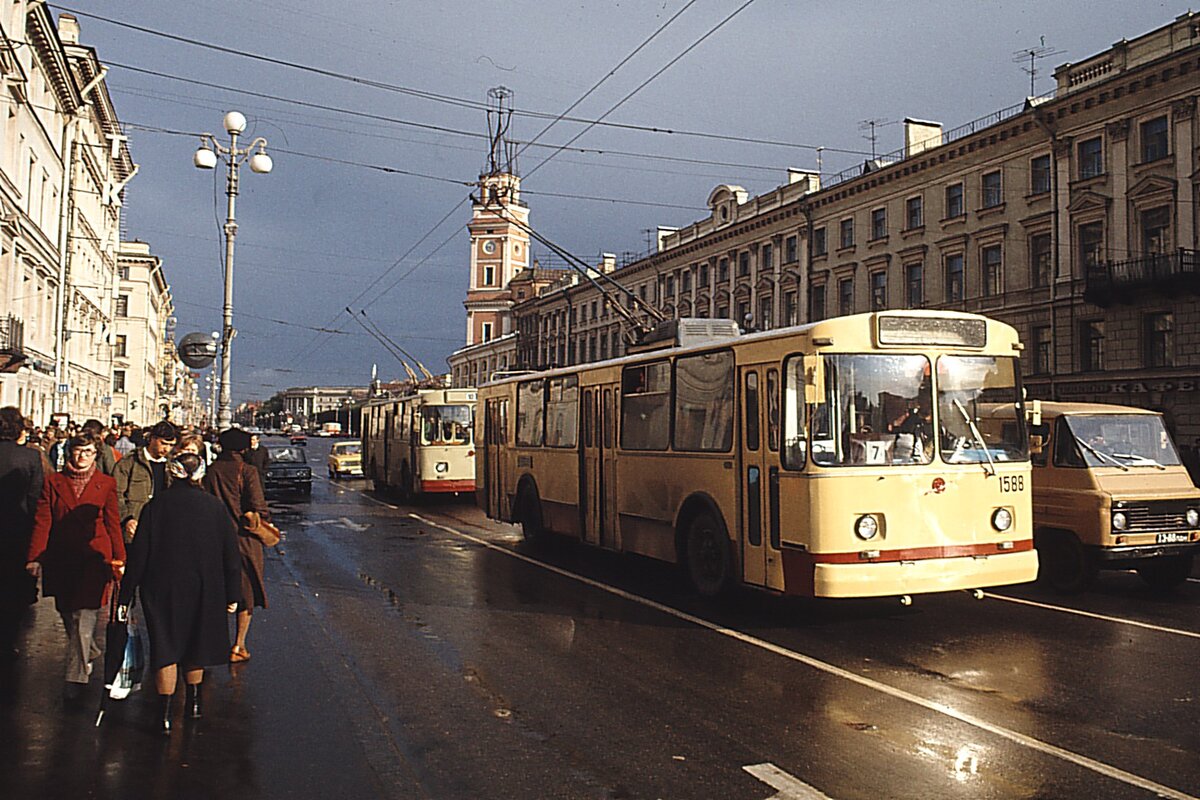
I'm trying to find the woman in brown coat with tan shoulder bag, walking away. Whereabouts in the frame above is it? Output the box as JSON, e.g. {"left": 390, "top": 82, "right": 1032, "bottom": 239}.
{"left": 204, "top": 428, "right": 270, "bottom": 663}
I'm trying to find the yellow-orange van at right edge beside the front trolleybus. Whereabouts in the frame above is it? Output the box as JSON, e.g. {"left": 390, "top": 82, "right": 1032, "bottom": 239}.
{"left": 1031, "top": 402, "right": 1200, "bottom": 593}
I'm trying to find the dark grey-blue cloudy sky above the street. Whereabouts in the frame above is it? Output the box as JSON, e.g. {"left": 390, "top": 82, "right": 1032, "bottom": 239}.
{"left": 52, "top": 0, "right": 1187, "bottom": 403}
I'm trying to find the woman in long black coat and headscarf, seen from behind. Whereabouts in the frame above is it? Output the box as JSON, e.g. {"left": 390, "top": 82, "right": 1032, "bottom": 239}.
{"left": 120, "top": 453, "right": 241, "bottom": 733}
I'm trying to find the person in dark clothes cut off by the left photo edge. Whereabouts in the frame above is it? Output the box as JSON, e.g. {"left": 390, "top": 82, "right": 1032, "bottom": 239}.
{"left": 0, "top": 405, "right": 46, "bottom": 661}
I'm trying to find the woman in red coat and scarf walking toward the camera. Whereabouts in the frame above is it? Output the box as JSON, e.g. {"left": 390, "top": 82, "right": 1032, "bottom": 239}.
{"left": 25, "top": 437, "right": 125, "bottom": 699}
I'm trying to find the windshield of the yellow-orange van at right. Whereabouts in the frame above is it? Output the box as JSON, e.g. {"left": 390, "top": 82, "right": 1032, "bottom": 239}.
{"left": 1063, "top": 414, "right": 1180, "bottom": 467}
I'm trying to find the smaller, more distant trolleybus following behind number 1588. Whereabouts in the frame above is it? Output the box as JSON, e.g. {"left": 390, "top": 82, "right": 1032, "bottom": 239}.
{"left": 361, "top": 389, "right": 475, "bottom": 499}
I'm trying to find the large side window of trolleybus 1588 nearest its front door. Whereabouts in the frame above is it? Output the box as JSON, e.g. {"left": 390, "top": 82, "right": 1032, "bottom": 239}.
{"left": 674, "top": 350, "right": 734, "bottom": 452}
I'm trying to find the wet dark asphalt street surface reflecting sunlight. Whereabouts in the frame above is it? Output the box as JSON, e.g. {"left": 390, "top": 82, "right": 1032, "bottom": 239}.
{"left": 0, "top": 439, "right": 1200, "bottom": 800}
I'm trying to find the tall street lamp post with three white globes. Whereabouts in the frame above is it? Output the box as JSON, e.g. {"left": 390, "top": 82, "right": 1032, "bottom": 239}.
{"left": 192, "top": 112, "right": 272, "bottom": 431}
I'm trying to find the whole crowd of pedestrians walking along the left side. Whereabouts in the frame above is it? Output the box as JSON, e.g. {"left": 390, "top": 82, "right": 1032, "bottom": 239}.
{"left": 0, "top": 407, "right": 270, "bottom": 733}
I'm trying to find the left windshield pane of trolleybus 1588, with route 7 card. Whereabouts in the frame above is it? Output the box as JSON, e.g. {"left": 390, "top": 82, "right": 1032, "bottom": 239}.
{"left": 788, "top": 354, "right": 934, "bottom": 467}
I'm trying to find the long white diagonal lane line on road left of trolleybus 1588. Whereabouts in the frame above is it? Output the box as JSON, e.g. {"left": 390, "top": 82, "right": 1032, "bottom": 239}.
{"left": 408, "top": 512, "right": 1200, "bottom": 800}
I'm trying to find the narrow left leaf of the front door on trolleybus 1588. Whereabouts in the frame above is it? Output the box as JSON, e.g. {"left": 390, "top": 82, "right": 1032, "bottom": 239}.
{"left": 739, "top": 367, "right": 768, "bottom": 587}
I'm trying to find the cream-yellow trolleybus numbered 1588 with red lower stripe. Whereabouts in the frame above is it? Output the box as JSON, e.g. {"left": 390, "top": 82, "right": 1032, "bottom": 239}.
{"left": 476, "top": 311, "right": 1038, "bottom": 603}
